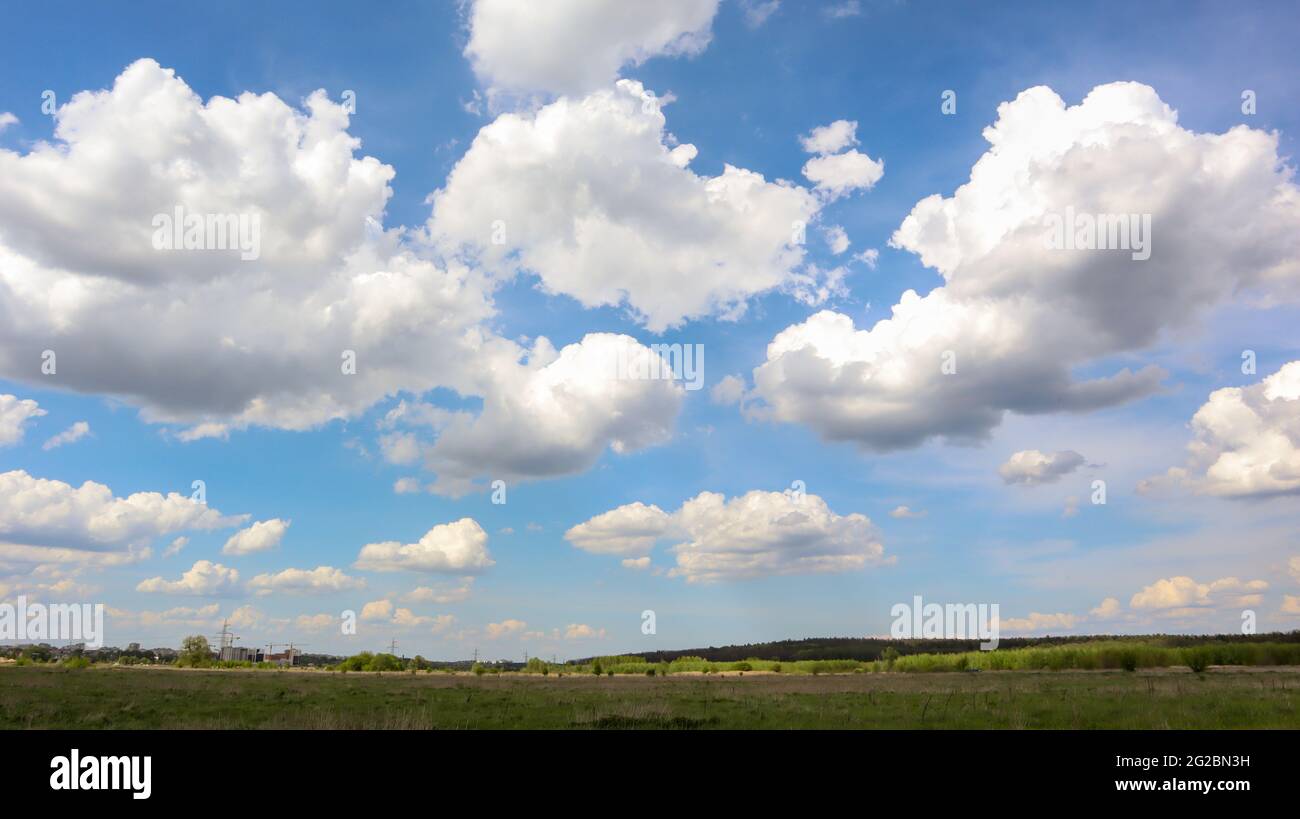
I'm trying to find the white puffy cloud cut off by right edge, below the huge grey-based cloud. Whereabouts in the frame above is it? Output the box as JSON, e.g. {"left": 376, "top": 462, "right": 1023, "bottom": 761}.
{"left": 1139, "top": 361, "right": 1300, "bottom": 498}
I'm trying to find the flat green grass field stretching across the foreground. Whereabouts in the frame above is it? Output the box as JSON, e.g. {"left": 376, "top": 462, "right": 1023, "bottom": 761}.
{"left": 0, "top": 663, "right": 1300, "bottom": 729}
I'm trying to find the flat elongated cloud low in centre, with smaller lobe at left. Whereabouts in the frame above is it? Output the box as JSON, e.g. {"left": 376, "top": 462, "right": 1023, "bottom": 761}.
{"left": 566, "top": 490, "right": 888, "bottom": 582}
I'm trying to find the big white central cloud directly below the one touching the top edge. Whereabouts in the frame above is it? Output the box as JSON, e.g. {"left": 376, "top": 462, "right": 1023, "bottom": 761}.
{"left": 429, "top": 81, "right": 819, "bottom": 332}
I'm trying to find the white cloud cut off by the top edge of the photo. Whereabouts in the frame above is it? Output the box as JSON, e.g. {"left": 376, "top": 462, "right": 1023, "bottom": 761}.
{"left": 465, "top": 0, "right": 718, "bottom": 94}
